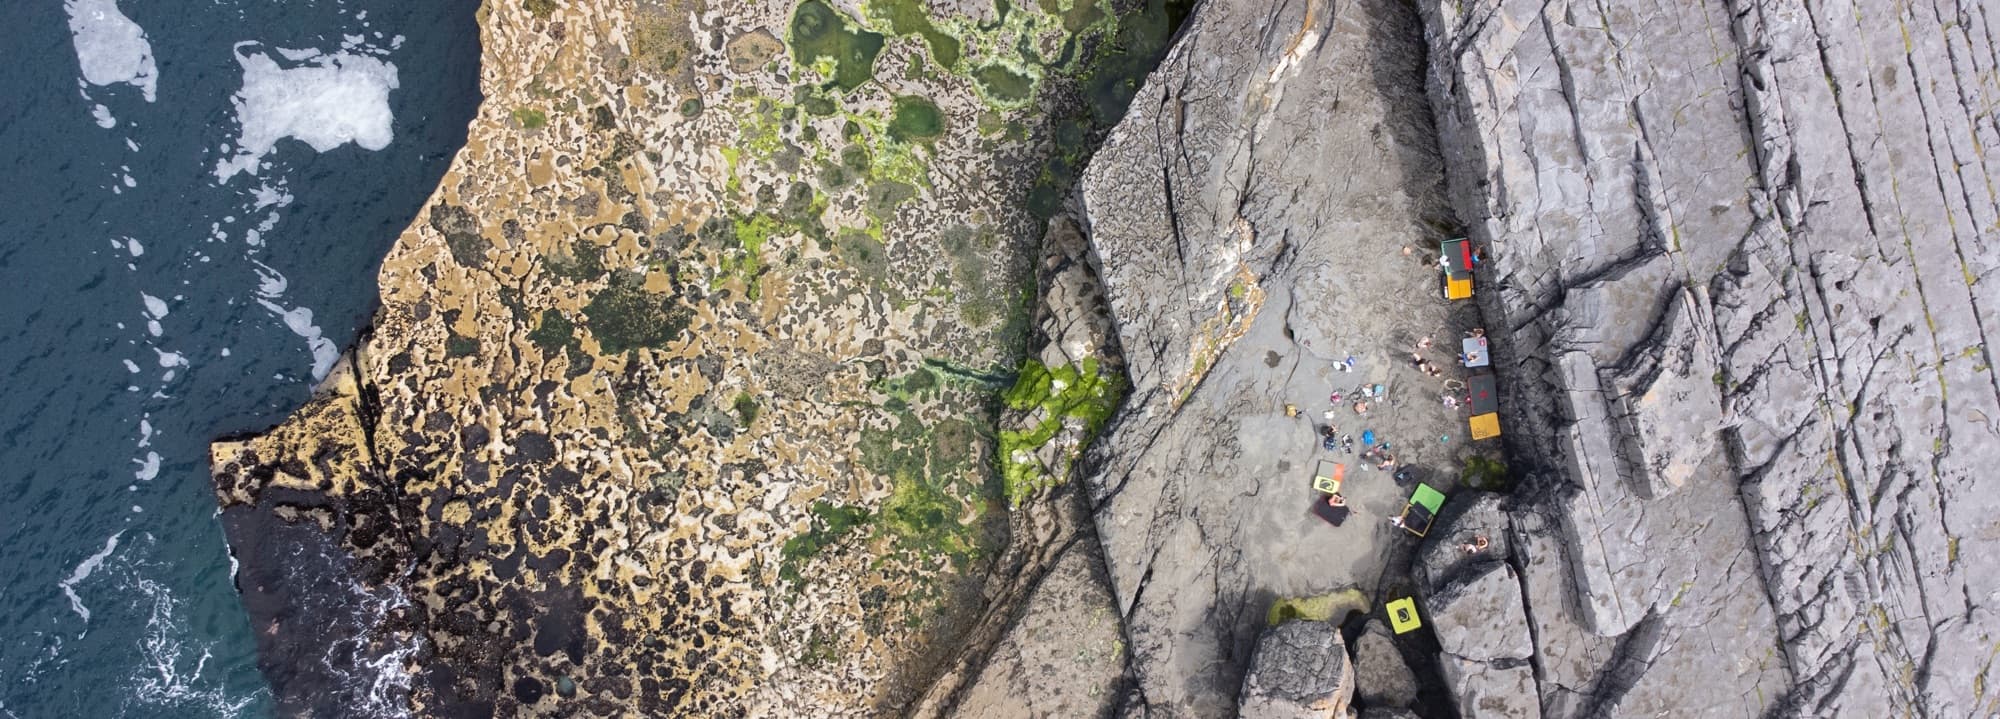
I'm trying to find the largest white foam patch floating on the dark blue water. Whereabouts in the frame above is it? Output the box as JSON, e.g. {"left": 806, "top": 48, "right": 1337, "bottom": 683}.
{"left": 216, "top": 42, "right": 398, "bottom": 182}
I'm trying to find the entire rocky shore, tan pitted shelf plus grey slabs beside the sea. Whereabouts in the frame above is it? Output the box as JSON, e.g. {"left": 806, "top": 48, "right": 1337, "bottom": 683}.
{"left": 214, "top": 0, "right": 2000, "bottom": 717}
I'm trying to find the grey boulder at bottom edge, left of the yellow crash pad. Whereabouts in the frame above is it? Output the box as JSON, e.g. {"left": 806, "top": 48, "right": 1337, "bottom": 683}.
{"left": 1238, "top": 621, "right": 1354, "bottom": 719}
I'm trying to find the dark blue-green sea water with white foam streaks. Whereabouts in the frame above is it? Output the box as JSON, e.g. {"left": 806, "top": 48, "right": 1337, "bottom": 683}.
{"left": 0, "top": 0, "right": 478, "bottom": 717}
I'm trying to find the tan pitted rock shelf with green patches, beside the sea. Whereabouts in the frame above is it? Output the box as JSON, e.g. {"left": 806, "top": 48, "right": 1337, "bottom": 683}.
{"left": 214, "top": 0, "right": 1172, "bottom": 717}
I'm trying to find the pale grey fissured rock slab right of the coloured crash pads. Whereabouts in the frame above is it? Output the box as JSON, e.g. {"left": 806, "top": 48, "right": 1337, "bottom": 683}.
{"left": 1418, "top": 0, "right": 2000, "bottom": 717}
